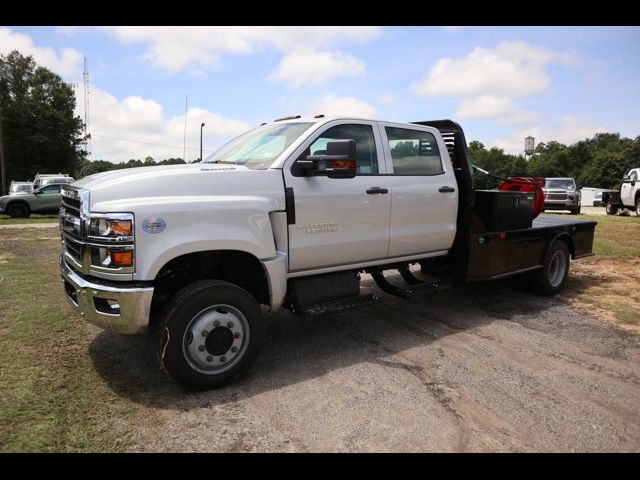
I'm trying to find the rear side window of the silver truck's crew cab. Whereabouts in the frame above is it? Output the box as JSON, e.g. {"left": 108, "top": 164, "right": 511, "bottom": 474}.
{"left": 385, "top": 127, "right": 444, "bottom": 175}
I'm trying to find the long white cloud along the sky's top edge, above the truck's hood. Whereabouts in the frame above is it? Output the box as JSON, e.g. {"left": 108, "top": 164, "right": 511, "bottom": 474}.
{"left": 88, "top": 26, "right": 380, "bottom": 72}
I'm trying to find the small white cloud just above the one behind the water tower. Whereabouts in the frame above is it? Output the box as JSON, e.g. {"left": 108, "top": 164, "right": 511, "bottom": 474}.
{"left": 455, "top": 95, "right": 541, "bottom": 123}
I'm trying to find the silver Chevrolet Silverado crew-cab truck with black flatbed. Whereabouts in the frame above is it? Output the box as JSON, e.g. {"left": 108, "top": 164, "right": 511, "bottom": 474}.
{"left": 60, "top": 115, "right": 595, "bottom": 389}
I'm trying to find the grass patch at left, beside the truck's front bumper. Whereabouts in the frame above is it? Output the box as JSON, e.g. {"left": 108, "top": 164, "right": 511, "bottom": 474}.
{"left": 0, "top": 229, "right": 141, "bottom": 452}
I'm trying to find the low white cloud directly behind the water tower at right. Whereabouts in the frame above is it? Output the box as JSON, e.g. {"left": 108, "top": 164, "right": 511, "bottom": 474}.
{"left": 487, "top": 115, "right": 610, "bottom": 154}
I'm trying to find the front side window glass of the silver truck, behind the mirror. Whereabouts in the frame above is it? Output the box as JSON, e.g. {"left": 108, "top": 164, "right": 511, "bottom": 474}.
{"left": 306, "top": 124, "right": 378, "bottom": 175}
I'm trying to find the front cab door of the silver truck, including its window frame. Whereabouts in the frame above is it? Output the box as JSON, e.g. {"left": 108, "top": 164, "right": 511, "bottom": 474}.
{"left": 283, "top": 120, "right": 391, "bottom": 272}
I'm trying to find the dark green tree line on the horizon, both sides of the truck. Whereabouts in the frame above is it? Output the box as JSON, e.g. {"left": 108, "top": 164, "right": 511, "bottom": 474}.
{"left": 0, "top": 51, "right": 640, "bottom": 195}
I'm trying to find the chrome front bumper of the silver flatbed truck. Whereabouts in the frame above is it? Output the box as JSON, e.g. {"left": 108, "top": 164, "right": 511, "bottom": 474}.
{"left": 60, "top": 257, "right": 153, "bottom": 333}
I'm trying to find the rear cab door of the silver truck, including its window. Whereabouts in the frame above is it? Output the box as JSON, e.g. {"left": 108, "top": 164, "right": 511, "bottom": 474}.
{"left": 380, "top": 123, "right": 459, "bottom": 257}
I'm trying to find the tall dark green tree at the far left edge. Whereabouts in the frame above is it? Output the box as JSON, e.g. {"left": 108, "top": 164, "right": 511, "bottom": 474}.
{"left": 0, "top": 50, "right": 84, "bottom": 191}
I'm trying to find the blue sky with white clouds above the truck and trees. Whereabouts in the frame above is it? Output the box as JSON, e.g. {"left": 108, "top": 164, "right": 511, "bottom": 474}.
{"left": 0, "top": 27, "right": 640, "bottom": 162}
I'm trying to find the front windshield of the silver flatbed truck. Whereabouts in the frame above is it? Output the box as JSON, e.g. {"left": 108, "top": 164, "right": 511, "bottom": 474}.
{"left": 203, "top": 122, "right": 313, "bottom": 170}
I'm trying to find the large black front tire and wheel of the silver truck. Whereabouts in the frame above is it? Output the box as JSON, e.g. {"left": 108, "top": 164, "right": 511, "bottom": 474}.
{"left": 156, "top": 280, "right": 265, "bottom": 390}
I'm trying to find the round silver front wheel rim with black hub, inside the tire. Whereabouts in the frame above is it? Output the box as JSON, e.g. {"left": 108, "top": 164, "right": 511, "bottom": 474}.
{"left": 182, "top": 304, "right": 249, "bottom": 375}
